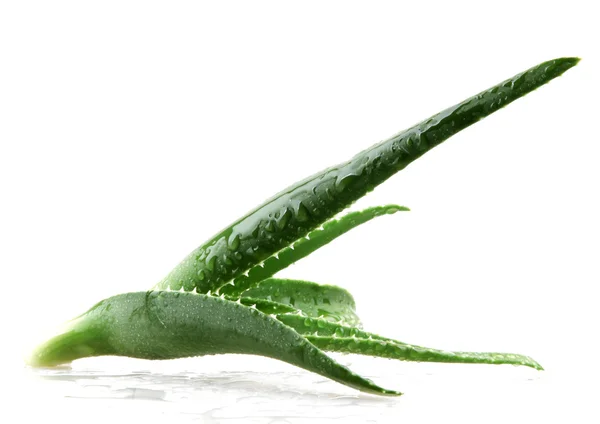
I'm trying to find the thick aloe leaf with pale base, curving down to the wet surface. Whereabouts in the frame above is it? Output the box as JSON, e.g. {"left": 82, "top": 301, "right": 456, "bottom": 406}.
{"left": 30, "top": 291, "right": 400, "bottom": 395}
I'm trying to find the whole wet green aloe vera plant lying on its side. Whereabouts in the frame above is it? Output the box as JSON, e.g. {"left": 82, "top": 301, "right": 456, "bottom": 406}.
{"left": 30, "top": 58, "right": 579, "bottom": 395}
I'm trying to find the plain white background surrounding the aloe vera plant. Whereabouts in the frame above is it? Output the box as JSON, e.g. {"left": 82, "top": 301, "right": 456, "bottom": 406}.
{"left": 0, "top": 0, "right": 600, "bottom": 422}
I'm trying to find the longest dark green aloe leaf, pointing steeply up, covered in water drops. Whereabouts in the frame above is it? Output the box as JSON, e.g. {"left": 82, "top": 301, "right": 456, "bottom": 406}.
{"left": 156, "top": 57, "right": 579, "bottom": 293}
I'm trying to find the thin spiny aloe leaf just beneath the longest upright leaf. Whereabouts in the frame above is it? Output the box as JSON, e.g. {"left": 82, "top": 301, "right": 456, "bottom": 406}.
{"left": 218, "top": 205, "right": 409, "bottom": 296}
